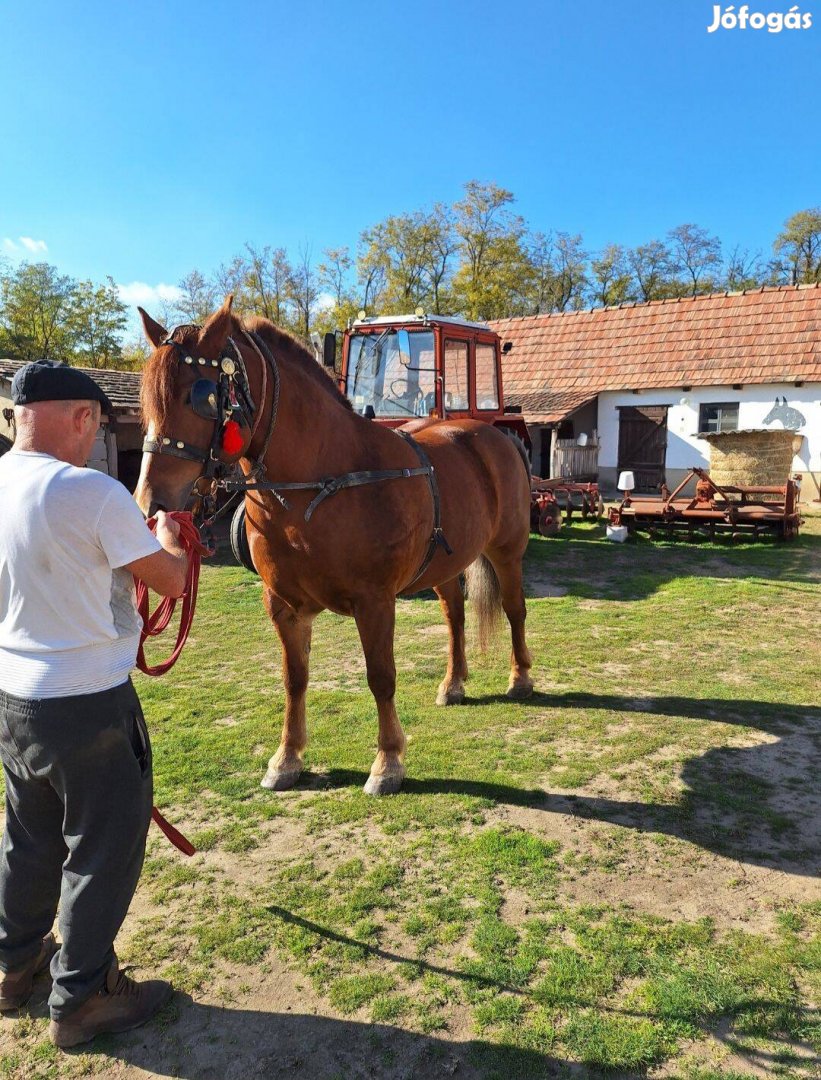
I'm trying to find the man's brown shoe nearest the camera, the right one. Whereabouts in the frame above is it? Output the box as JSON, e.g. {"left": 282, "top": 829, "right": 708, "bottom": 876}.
{"left": 49, "top": 959, "right": 174, "bottom": 1048}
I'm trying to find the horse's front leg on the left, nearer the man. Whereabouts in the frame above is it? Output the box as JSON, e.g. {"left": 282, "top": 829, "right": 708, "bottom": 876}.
{"left": 263, "top": 605, "right": 313, "bottom": 792}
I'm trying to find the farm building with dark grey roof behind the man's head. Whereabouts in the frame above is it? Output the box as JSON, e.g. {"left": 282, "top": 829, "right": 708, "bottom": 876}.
{"left": 0, "top": 360, "right": 143, "bottom": 491}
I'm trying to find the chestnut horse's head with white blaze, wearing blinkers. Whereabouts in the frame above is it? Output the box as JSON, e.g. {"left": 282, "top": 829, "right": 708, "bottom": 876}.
{"left": 134, "top": 296, "right": 251, "bottom": 516}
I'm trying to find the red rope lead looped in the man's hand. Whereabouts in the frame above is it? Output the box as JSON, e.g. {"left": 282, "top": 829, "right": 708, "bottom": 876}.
{"left": 134, "top": 511, "right": 213, "bottom": 855}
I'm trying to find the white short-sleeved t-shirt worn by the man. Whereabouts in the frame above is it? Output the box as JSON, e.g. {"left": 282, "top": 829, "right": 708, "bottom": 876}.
{"left": 0, "top": 449, "right": 161, "bottom": 698}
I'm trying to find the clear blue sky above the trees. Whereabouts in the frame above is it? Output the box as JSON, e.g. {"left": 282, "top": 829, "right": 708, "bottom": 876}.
{"left": 0, "top": 0, "right": 821, "bottom": 315}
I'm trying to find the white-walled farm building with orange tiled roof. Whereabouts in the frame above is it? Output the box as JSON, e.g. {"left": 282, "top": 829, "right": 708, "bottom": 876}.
{"left": 492, "top": 285, "right": 821, "bottom": 501}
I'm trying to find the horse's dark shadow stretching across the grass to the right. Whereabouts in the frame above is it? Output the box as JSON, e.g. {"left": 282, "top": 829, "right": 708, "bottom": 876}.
{"left": 306, "top": 693, "right": 821, "bottom": 876}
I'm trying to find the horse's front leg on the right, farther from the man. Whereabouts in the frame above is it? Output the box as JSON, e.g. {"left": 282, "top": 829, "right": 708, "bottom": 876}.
{"left": 354, "top": 596, "right": 405, "bottom": 795}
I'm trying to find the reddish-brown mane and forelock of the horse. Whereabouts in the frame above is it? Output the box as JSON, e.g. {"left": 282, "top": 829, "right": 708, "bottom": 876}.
{"left": 139, "top": 315, "right": 352, "bottom": 434}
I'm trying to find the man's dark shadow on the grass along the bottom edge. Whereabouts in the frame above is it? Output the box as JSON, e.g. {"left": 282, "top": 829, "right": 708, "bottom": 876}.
{"left": 49, "top": 984, "right": 812, "bottom": 1080}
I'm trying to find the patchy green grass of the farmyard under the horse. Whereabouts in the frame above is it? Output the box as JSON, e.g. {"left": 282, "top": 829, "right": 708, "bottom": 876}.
{"left": 0, "top": 518, "right": 821, "bottom": 1080}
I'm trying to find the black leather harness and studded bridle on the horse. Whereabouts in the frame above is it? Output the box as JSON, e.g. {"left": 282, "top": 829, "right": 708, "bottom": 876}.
{"left": 137, "top": 326, "right": 453, "bottom": 593}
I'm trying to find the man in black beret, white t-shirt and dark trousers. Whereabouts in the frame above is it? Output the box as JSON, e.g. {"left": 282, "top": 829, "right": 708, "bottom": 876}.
{"left": 0, "top": 361, "right": 188, "bottom": 1047}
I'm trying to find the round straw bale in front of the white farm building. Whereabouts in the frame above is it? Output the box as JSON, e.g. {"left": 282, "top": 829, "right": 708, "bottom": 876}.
{"left": 700, "top": 429, "right": 802, "bottom": 487}
